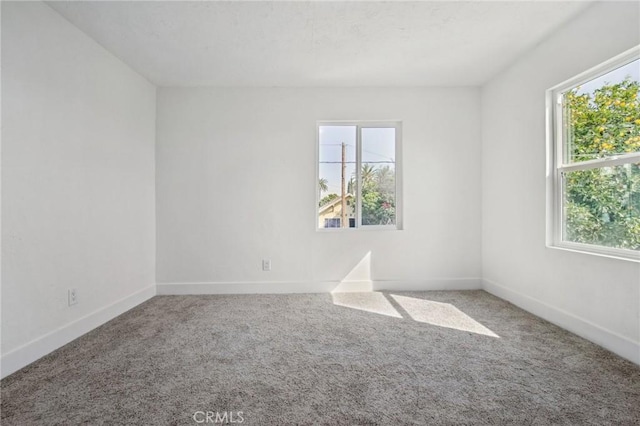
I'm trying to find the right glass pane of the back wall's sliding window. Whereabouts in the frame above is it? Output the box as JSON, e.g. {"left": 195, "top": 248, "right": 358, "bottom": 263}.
{"left": 360, "top": 128, "right": 396, "bottom": 225}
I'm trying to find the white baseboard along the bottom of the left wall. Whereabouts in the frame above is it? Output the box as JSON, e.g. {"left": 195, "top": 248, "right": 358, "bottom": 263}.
{"left": 0, "top": 285, "right": 156, "bottom": 378}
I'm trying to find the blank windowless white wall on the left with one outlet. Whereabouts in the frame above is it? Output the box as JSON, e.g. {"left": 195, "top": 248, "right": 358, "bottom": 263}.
{"left": 2, "top": 2, "right": 155, "bottom": 375}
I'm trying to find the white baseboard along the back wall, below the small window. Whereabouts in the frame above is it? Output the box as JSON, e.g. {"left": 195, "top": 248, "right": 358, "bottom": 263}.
{"left": 157, "top": 278, "right": 482, "bottom": 295}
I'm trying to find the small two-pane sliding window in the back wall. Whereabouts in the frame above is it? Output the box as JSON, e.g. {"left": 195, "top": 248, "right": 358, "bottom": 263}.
{"left": 316, "top": 122, "right": 401, "bottom": 229}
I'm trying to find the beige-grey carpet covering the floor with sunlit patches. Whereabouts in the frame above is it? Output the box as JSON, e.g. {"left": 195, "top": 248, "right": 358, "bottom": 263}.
{"left": 1, "top": 291, "right": 640, "bottom": 426}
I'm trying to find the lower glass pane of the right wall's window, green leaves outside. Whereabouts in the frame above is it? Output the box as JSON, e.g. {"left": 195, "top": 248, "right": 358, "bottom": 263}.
{"left": 563, "top": 163, "right": 640, "bottom": 250}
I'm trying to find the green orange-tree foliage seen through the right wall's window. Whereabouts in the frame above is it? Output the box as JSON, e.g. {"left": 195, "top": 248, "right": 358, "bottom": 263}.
{"left": 565, "top": 78, "right": 640, "bottom": 250}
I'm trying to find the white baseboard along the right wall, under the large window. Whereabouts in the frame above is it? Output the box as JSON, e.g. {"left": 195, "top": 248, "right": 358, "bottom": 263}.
{"left": 482, "top": 279, "right": 640, "bottom": 365}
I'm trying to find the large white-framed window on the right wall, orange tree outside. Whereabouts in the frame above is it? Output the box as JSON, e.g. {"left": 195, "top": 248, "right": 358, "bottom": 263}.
{"left": 547, "top": 48, "right": 640, "bottom": 260}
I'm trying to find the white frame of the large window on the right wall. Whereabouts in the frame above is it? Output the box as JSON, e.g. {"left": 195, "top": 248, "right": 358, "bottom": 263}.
{"left": 546, "top": 46, "right": 640, "bottom": 262}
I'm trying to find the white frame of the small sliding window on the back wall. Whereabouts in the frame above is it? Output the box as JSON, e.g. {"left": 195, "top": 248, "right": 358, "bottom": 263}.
{"left": 314, "top": 120, "right": 402, "bottom": 232}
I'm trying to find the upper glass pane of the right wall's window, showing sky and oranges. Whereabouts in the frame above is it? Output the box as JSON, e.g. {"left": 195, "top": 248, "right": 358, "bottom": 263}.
{"left": 563, "top": 60, "right": 640, "bottom": 163}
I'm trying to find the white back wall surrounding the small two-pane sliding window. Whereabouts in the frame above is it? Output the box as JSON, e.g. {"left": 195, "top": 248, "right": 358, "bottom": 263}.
{"left": 156, "top": 88, "right": 481, "bottom": 293}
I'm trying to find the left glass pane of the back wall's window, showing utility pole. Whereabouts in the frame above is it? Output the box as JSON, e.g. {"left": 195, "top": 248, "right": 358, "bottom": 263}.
{"left": 318, "top": 126, "right": 356, "bottom": 228}
